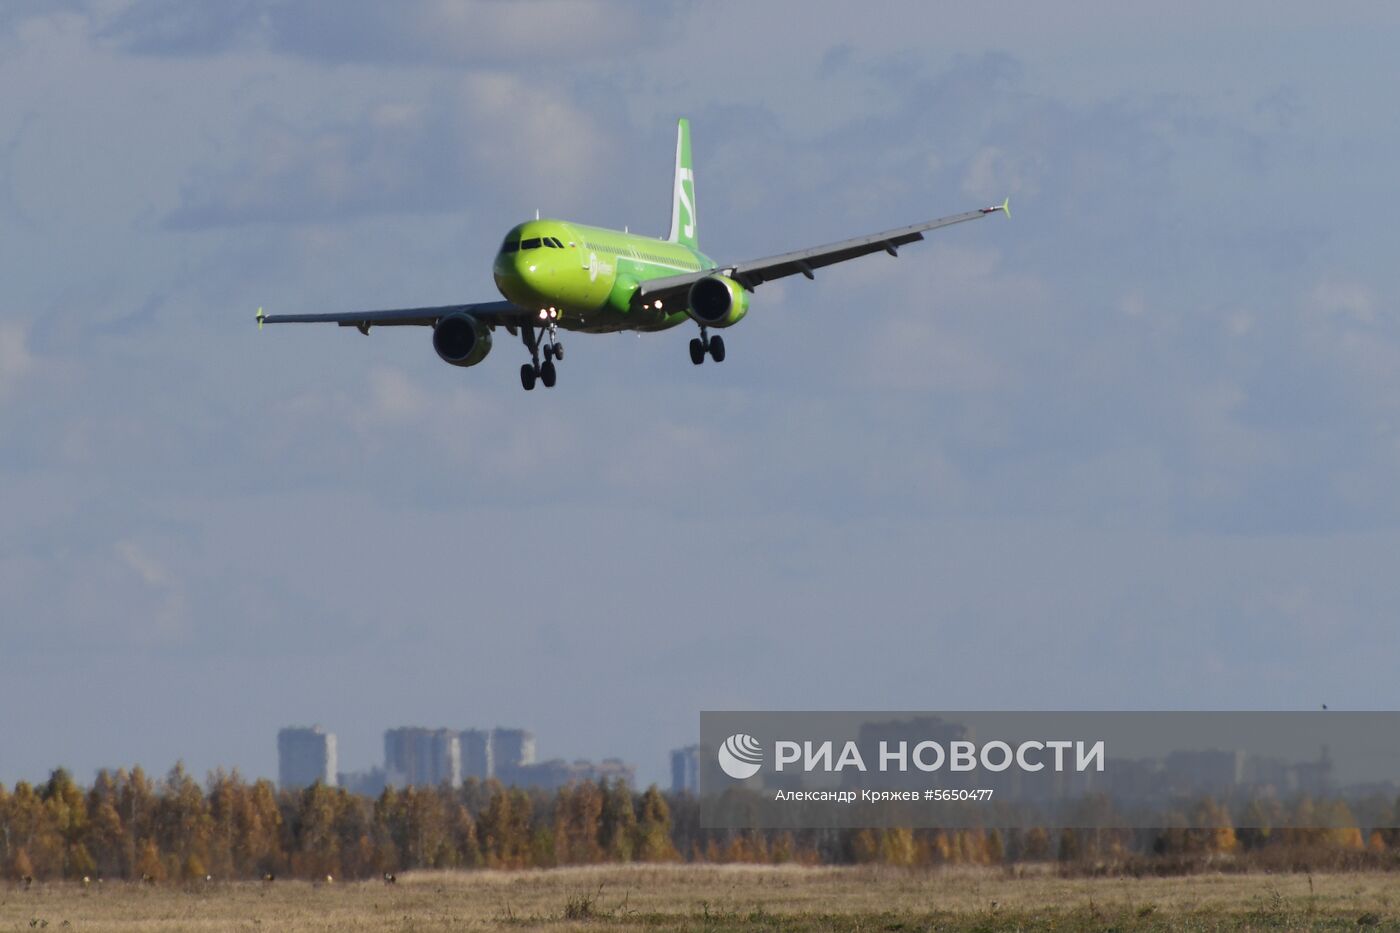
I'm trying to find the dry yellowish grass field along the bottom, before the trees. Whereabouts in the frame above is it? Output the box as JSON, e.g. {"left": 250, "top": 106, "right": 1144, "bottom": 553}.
{"left": 0, "top": 866, "right": 1400, "bottom": 933}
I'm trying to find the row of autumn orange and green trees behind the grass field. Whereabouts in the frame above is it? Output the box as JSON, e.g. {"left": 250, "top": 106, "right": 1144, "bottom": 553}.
{"left": 0, "top": 765, "right": 1400, "bottom": 881}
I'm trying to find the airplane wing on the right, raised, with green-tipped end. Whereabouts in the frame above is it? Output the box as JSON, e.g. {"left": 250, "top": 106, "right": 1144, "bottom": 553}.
{"left": 637, "top": 198, "right": 1011, "bottom": 304}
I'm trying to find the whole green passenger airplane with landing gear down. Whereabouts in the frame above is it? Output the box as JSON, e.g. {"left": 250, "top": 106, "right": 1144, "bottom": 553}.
{"left": 258, "top": 119, "right": 1011, "bottom": 391}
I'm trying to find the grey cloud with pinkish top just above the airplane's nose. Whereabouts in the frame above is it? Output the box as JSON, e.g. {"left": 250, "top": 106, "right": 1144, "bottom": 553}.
{"left": 167, "top": 71, "right": 620, "bottom": 228}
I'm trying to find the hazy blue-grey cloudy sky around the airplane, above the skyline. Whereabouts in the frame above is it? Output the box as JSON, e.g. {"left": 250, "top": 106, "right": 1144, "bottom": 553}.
{"left": 0, "top": 0, "right": 1400, "bottom": 783}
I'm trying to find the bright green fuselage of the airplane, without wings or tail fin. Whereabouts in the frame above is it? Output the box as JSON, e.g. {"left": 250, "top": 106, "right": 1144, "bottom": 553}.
{"left": 493, "top": 220, "right": 714, "bottom": 333}
